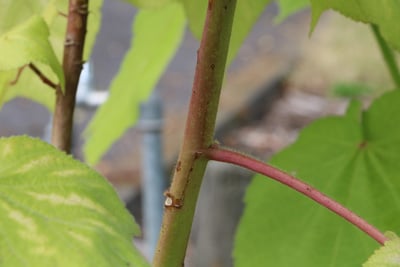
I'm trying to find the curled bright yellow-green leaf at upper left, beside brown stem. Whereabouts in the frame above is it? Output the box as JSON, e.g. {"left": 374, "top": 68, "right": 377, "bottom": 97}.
{"left": 0, "top": 15, "right": 65, "bottom": 90}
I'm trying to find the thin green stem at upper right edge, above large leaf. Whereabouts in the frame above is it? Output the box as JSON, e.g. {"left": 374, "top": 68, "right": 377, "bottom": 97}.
{"left": 371, "top": 24, "right": 400, "bottom": 89}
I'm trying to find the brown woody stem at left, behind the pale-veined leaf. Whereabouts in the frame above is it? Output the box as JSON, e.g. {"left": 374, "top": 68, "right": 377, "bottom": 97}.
{"left": 51, "top": 0, "right": 89, "bottom": 153}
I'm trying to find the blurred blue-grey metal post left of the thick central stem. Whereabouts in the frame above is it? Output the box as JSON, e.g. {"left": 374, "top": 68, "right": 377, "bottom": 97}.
{"left": 139, "top": 92, "right": 165, "bottom": 259}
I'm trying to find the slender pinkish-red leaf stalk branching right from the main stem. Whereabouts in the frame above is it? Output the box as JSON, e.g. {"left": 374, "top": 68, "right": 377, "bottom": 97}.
{"left": 202, "top": 145, "right": 387, "bottom": 245}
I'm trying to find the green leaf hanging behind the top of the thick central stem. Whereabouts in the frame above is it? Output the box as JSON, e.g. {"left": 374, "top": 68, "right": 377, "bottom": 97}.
{"left": 181, "top": 0, "right": 271, "bottom": 64}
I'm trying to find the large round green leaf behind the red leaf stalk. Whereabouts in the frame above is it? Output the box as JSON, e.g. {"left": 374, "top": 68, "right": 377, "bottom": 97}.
{"left": 234, "top": 90, "right": 400, "bottom": 267}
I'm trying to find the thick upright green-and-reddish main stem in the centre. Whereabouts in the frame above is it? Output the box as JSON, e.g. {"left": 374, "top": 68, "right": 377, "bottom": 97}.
{"left": 153, "top": 0, "right": 236, "bottom": 267}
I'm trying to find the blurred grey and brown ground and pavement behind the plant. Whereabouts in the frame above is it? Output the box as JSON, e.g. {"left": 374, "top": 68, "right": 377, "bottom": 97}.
{"left": 0, "top": 0, "right": 391, "bottom": 266}
